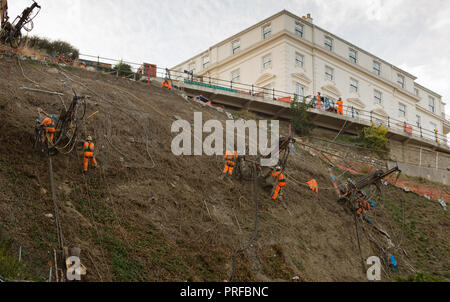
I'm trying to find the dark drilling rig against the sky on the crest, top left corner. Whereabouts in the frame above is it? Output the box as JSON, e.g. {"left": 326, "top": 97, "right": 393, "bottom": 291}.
{"left": 0, "top": 0, "right": 41, "bottom": 48}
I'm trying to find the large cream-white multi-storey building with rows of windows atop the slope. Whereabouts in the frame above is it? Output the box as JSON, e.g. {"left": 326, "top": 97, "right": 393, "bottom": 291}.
{"left": 172, "top": 10, "right": 450, "bottom": 139}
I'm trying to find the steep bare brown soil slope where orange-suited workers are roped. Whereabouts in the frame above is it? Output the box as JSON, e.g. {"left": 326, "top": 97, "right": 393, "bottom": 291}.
{"left": 0, "top": 58, "right": 449, "bottom": 281}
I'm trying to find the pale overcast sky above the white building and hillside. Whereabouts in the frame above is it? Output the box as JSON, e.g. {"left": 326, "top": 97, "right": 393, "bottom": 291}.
{"left": 9, "top": 0, "right": 450, "bottom": 115}
